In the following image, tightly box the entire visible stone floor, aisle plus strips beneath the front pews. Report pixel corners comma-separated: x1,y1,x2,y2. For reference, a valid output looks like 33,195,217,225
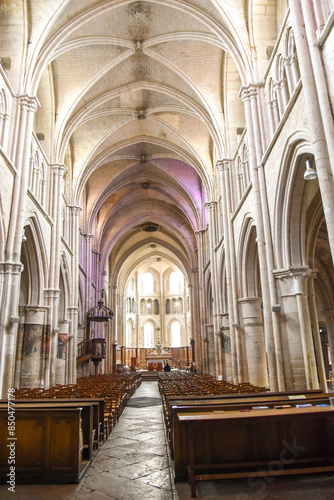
0,382,334,500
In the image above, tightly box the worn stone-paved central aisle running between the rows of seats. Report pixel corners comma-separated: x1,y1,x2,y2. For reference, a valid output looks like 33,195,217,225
74,382,179,500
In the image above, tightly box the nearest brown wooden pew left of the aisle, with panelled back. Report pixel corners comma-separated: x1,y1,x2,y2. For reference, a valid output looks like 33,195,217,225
0,406,88,484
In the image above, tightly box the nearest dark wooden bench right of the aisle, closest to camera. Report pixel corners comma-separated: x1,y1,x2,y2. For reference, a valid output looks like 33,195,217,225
177,406,334,498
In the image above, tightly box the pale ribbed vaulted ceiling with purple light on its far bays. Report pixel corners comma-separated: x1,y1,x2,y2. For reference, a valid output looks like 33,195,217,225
2,0,285,284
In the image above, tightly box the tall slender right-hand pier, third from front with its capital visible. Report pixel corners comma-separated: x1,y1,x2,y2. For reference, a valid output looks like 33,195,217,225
205,201,222,377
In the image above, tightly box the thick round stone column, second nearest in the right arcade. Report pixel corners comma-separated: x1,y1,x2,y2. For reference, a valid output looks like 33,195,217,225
239,297,269,387
